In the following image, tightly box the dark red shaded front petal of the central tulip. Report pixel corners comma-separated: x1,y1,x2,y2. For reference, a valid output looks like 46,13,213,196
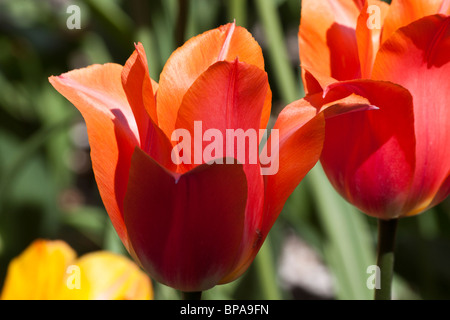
125,148,247,291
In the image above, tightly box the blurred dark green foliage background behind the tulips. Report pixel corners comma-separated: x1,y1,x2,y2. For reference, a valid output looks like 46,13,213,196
0,0,450,299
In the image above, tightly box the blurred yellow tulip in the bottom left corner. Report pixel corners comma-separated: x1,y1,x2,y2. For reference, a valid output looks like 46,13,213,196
0,239,153,300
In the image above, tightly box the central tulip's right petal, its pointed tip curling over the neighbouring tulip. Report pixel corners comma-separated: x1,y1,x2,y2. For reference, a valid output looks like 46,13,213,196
225,93,376,282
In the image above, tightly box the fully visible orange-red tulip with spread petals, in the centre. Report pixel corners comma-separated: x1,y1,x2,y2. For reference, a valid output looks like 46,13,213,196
50,23,367,292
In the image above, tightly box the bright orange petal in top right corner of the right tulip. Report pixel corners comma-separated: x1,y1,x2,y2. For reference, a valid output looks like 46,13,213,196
381,0,450,43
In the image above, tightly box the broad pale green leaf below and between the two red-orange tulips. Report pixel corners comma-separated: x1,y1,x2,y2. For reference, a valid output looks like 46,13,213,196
307,165,376,300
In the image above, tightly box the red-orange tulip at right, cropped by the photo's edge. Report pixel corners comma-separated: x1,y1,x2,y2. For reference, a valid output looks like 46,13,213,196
299,0,450,219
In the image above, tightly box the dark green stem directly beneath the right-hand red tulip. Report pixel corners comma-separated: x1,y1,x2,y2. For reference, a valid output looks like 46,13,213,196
375,219,398,300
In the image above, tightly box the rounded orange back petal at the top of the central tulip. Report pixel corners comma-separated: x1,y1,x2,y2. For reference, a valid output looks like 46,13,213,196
157,23,271,137
